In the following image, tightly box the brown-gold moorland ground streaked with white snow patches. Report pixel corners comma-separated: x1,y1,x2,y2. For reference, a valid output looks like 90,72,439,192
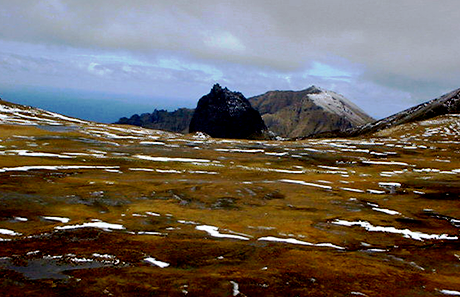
0,104,460,296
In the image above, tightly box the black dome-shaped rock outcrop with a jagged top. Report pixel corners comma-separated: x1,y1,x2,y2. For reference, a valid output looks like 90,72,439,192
189,84,267,139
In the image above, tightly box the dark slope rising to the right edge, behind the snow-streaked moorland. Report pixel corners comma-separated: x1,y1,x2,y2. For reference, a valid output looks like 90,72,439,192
345,89,460,136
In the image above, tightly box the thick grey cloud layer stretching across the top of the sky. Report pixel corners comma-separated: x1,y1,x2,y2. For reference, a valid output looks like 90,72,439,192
0,0,460,71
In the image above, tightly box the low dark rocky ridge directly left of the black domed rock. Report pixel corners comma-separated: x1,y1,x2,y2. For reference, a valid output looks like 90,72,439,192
115,108,194,133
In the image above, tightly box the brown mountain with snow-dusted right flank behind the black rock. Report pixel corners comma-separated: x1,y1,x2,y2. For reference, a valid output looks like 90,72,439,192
249,86,374,138
